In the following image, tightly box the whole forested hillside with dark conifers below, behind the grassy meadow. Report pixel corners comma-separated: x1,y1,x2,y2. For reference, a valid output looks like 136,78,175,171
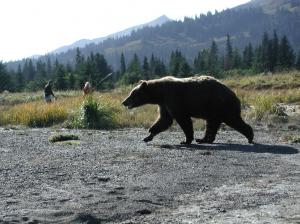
0,0,300,91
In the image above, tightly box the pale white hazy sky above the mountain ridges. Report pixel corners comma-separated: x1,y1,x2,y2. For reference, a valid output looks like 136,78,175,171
0,0,249,61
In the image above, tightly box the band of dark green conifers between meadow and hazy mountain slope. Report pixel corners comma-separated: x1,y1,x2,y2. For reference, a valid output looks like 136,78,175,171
0,31,300,92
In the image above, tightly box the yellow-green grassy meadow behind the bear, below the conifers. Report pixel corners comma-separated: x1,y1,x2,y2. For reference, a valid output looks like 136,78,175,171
0,71,300,129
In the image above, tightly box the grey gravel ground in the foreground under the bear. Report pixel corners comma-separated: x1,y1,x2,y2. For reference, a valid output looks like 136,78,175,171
0,128,300,224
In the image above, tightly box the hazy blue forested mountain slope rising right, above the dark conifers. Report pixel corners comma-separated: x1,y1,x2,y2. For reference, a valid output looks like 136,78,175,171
8,0,300,70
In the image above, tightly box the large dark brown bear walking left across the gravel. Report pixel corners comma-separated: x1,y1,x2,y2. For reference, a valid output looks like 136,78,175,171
122,76,253,144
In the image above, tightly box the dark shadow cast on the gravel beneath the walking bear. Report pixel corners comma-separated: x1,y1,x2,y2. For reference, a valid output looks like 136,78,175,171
158,143,299,154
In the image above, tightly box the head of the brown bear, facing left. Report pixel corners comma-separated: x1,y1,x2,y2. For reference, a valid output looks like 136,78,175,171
122,81,150,109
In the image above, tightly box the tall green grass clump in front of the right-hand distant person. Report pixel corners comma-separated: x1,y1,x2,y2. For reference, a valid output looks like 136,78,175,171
72,95,117,129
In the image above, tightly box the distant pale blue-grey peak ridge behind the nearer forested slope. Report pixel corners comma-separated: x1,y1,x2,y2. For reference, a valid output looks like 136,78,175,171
51,15,172,54
